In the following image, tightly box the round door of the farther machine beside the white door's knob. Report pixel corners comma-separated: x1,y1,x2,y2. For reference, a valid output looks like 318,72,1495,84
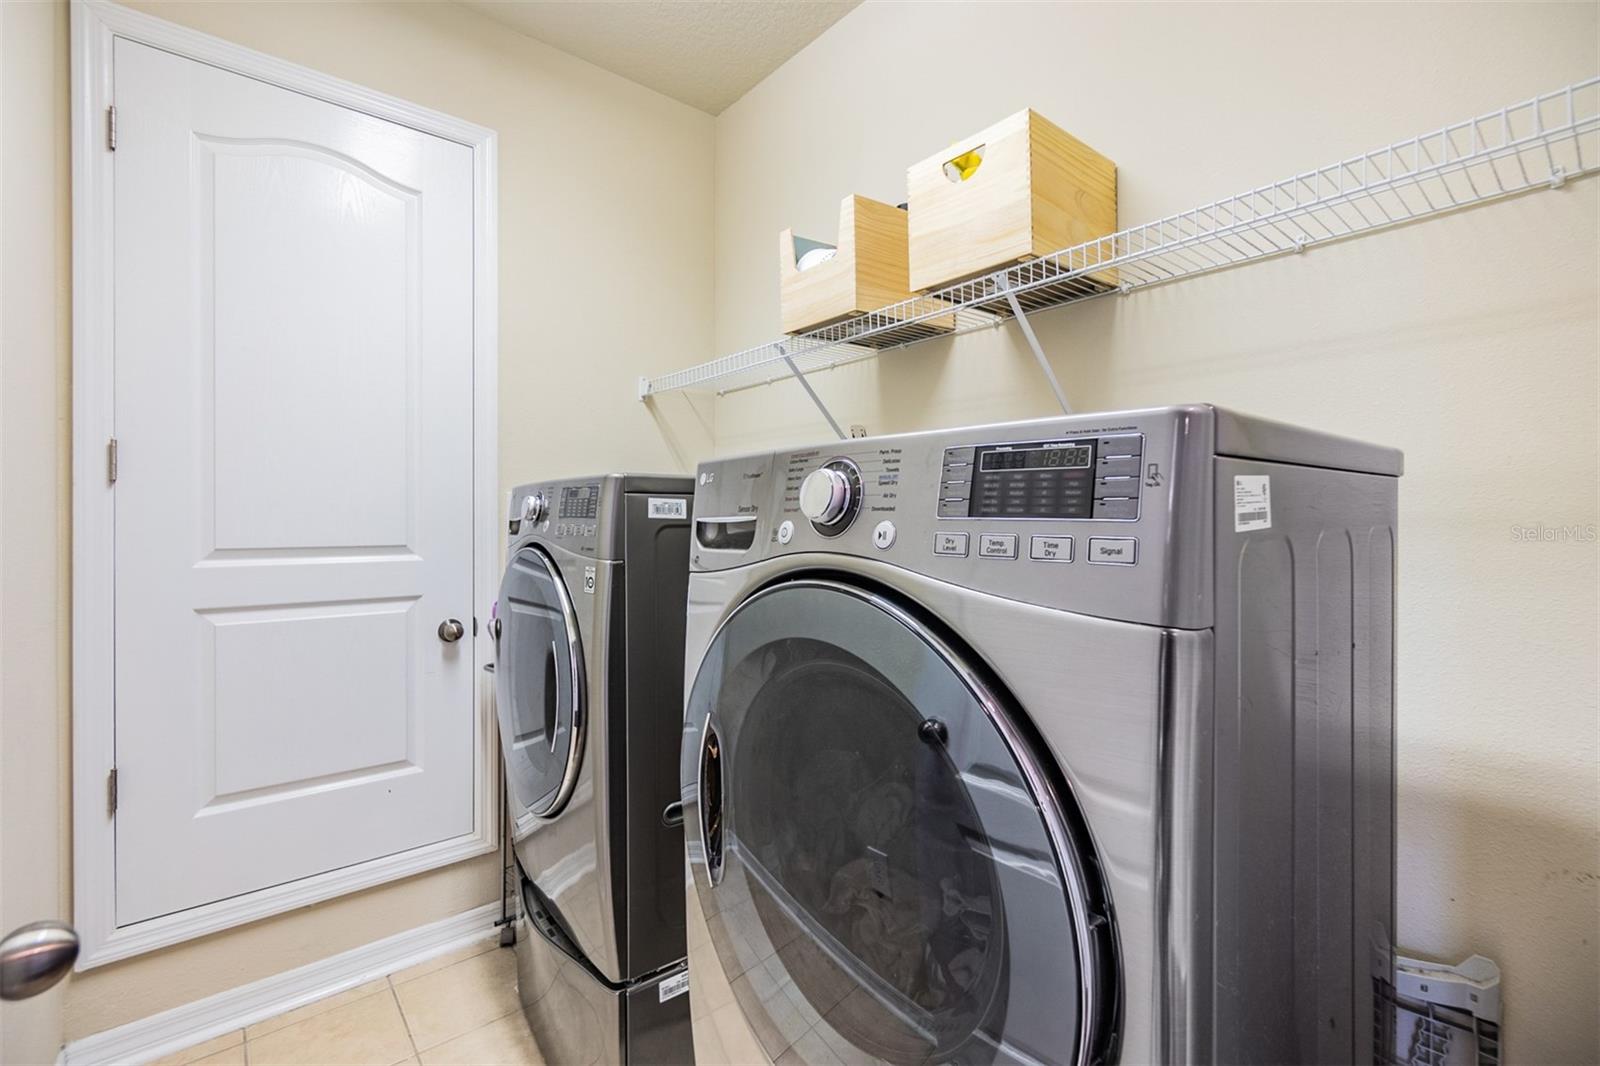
494,547,584,821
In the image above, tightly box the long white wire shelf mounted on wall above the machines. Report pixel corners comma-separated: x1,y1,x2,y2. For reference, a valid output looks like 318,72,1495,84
638,77,1600,404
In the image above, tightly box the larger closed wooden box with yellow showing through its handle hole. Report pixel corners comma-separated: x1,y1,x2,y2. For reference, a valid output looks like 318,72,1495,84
906,110,1117,291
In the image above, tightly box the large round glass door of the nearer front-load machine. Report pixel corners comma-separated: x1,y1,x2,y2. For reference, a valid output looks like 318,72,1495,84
682,579,1118,1063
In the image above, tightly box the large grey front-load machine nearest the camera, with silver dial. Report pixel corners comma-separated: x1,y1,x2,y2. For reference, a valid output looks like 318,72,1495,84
680,407,1400,1064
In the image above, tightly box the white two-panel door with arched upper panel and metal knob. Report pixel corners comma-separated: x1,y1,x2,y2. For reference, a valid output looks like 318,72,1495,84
114,38,474,925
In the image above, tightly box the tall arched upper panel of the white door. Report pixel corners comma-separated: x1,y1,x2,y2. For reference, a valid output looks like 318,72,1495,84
203,136,419,551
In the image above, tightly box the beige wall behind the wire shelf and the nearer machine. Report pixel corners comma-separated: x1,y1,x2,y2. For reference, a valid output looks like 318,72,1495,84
715,3,1600,1061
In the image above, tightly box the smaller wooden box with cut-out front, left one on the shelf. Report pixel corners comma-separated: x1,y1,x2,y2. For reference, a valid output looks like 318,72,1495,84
778,197,910,333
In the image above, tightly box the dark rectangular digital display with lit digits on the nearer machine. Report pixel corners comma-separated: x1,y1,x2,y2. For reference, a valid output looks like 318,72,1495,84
968,440,1094,519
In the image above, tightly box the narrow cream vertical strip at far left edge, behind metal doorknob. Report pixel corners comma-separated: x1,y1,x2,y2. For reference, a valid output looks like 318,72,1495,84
0,3,72,1063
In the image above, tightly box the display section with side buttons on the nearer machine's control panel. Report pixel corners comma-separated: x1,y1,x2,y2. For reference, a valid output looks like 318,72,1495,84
938,434,1144,522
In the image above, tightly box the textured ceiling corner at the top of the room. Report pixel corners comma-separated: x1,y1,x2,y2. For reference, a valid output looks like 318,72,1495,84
459,0,861,115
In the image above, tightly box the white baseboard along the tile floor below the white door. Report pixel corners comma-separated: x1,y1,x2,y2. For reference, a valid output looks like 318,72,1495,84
58,903,499,1066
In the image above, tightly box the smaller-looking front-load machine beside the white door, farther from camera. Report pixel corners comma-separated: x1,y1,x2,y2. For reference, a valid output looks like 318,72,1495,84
491,474,694,1066
